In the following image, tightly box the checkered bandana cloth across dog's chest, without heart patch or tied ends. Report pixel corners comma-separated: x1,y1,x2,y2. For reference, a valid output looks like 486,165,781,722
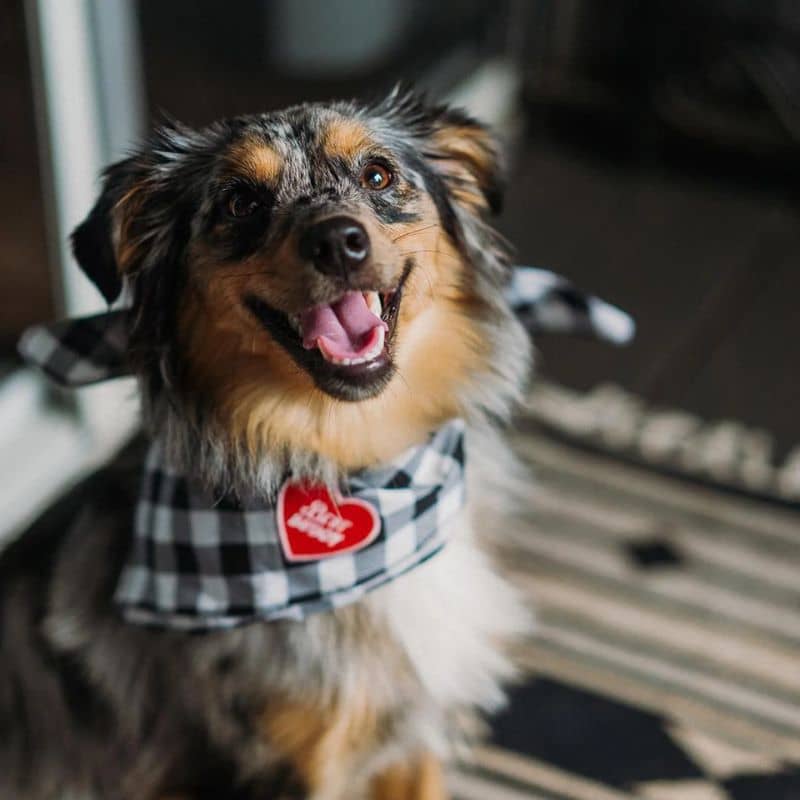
111,420,464,631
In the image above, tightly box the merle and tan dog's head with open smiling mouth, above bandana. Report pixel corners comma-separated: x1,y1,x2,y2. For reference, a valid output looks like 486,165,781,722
73,93,527,482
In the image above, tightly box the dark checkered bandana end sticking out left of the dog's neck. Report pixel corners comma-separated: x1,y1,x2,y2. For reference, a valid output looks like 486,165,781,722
18,309,130,386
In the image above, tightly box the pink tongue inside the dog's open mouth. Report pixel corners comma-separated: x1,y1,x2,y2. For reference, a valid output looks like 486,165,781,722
300,292,388,358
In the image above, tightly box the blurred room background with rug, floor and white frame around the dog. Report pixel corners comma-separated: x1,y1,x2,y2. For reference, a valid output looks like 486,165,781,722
0,0,800,800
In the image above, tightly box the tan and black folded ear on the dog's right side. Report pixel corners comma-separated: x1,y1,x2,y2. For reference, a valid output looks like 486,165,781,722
424,106,504,214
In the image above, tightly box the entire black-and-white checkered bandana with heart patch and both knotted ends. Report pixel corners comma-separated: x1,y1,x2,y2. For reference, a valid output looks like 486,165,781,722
19,267,633,631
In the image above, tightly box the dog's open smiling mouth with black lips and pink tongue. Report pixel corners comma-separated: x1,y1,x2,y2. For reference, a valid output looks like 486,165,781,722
245,264,411,400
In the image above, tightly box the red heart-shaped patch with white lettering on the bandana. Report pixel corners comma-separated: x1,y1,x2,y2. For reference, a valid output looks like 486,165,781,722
278,481,381,561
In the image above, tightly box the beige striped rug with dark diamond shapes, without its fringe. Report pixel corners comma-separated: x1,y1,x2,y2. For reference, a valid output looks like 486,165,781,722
452,430,800,800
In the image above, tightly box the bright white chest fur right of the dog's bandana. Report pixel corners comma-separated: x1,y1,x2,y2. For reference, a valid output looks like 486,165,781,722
367,430,532,728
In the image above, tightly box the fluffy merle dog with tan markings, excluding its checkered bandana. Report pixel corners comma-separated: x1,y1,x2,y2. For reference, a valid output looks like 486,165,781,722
0,90,544,800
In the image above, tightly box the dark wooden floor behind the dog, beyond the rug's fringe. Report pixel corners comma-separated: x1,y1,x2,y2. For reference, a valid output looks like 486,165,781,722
502,119,800,456
